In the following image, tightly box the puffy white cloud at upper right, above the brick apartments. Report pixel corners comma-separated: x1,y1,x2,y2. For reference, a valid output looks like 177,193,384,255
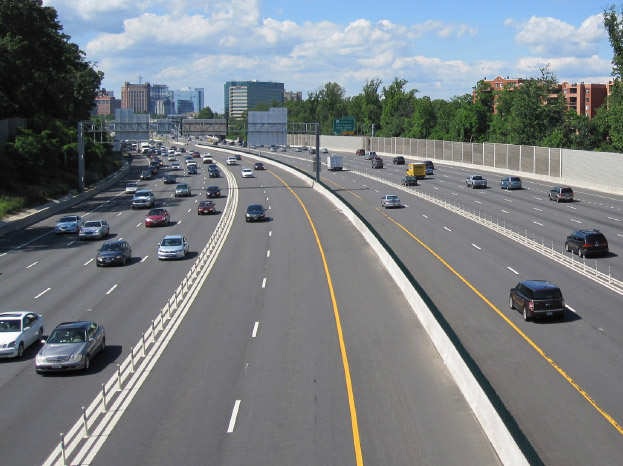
515,14,607,57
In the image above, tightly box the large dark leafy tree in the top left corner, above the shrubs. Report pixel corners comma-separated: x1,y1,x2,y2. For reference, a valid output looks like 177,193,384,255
0,0,103,124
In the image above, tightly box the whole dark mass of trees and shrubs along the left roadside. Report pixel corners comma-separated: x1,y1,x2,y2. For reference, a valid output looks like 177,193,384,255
0,0,112,208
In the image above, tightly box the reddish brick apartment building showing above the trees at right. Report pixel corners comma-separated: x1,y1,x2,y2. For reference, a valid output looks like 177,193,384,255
472,76,613,118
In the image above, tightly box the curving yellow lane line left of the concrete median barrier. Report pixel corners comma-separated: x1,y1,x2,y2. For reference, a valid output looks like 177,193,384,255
268,170,363,466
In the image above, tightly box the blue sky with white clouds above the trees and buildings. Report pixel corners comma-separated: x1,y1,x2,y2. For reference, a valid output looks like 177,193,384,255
43,0,619,113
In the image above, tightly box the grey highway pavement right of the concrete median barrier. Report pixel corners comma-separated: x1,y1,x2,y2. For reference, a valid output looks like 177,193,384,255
258,144,623,464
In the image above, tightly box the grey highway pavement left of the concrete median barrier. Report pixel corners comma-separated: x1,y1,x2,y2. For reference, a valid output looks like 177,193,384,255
0,150,499,465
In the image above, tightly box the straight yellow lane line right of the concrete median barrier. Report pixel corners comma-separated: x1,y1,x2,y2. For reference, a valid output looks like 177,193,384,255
383,213,623,435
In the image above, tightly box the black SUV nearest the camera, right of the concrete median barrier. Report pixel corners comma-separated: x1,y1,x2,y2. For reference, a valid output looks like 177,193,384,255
509,280,565,322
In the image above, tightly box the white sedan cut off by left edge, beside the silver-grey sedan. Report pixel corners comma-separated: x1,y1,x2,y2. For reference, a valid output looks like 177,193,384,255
0,312,43,358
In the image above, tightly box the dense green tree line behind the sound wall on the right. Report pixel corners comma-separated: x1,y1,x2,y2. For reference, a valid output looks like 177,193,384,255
285,6,623,152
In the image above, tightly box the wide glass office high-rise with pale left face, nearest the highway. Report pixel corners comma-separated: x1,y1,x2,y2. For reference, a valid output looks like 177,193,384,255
224,80,284,118
